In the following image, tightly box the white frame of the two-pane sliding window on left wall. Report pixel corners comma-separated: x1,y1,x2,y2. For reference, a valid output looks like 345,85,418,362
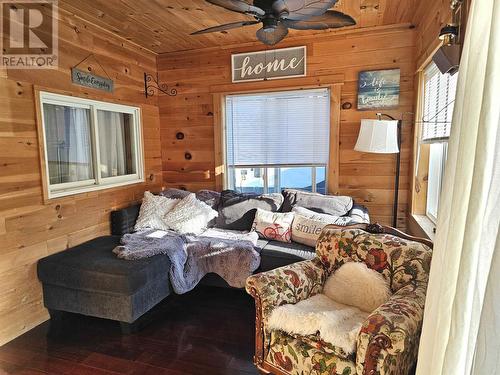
39,91,145,199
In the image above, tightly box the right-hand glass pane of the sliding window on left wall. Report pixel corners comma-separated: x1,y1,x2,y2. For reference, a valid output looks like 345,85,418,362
97,110,137,178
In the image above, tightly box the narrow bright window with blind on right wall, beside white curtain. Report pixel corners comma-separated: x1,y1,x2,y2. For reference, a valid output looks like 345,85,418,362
422,63,458,222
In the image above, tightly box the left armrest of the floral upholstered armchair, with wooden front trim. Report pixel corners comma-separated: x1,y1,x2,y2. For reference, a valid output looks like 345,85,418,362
246,258,327,368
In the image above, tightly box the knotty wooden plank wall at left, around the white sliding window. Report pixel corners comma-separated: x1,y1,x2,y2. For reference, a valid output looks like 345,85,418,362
0,11,161,345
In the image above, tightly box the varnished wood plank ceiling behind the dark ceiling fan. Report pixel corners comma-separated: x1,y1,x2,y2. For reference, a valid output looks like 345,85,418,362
59,0,417,53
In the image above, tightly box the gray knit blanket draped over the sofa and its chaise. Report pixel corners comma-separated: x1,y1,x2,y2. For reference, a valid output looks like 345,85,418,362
113,230,260,294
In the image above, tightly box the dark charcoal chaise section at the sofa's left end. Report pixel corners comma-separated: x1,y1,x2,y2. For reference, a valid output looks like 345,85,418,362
38,209,171,331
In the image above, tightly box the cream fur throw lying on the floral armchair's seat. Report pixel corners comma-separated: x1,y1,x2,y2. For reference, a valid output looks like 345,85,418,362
269,294,370,354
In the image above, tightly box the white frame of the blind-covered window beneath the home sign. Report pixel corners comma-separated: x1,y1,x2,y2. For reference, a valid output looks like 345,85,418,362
222,88,332,195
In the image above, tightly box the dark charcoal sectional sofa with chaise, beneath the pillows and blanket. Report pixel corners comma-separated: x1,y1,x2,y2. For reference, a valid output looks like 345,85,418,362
38,189,369,331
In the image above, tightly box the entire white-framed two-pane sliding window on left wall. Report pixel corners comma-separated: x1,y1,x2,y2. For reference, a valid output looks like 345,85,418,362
40,92,143,198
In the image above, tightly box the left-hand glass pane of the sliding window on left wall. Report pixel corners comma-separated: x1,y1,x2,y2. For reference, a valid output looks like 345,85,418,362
43,104,94,185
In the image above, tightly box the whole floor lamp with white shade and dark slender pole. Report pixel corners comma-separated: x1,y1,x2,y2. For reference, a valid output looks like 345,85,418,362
354,113,402,228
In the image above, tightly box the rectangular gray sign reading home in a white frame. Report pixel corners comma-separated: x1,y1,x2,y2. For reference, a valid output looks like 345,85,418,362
231,46,307,83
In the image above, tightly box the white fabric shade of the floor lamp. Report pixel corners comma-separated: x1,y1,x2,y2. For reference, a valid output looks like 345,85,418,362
354,120,399,154
